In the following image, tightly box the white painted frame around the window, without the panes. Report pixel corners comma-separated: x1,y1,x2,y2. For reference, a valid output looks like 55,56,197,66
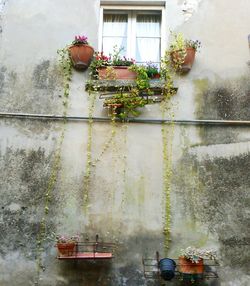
98,5,167,61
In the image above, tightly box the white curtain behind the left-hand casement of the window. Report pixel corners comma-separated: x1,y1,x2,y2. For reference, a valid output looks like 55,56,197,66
102,14,128,56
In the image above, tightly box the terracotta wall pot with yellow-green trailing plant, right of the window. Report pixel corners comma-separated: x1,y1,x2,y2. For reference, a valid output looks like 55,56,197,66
166,33,201,73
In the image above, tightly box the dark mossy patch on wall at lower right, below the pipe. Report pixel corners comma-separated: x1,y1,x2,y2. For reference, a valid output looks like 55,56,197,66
193,153,250,270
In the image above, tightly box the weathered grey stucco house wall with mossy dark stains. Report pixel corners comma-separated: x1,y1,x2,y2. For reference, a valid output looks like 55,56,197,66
0,0,250,286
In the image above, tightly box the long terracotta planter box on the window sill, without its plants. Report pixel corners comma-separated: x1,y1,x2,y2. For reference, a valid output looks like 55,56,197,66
98,66,136,79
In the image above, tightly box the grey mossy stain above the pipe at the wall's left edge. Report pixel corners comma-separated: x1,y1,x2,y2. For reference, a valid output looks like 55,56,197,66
0,60,62,114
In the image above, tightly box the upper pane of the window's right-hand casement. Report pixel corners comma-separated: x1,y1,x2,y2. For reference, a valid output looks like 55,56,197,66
136,14,161,37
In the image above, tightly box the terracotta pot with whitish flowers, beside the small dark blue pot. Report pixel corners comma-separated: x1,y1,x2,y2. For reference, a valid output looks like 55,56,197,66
179,246,216,274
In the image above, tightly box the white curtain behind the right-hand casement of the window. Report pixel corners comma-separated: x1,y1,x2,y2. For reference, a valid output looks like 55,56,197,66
136,15,161,63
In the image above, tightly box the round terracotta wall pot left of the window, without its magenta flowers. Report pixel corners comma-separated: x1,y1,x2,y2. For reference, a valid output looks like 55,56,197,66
69,44,94,70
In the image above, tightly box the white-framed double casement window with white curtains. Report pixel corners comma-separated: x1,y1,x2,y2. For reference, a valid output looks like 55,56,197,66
99,6,165,65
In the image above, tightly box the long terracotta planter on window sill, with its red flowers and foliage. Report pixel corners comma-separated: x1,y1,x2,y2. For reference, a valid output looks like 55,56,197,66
90,46,136,80
